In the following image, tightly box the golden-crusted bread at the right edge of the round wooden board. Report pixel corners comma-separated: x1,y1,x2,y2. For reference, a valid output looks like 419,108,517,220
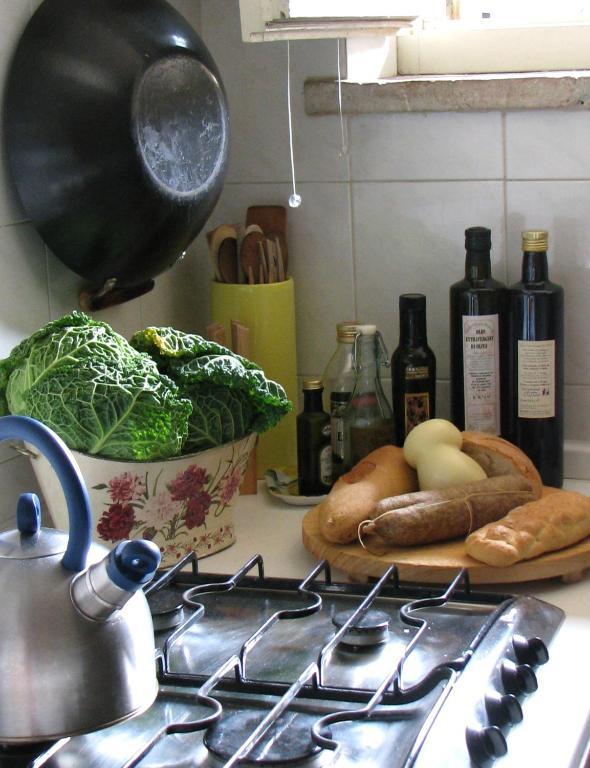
465,491,590,567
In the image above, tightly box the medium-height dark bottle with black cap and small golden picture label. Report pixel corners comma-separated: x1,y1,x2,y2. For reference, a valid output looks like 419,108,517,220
391,293,436,446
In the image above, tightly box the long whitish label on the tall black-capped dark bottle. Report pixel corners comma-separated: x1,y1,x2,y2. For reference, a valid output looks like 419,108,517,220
463,315,500,435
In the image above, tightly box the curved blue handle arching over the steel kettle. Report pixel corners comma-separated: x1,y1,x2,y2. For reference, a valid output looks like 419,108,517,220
0,416,92,571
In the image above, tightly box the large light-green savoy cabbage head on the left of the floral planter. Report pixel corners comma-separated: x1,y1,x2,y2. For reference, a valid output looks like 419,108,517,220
0,312,192,461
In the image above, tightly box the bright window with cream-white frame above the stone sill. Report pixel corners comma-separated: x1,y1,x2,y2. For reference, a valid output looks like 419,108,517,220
240,0,590,81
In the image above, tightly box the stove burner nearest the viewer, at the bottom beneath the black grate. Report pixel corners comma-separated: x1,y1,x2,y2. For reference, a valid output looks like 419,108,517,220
204,710,323,766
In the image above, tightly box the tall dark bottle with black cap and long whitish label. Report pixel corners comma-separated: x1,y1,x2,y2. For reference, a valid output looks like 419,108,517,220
450,227,508,435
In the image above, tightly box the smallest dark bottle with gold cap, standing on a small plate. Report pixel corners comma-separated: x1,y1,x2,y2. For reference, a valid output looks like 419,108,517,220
297,379,332,496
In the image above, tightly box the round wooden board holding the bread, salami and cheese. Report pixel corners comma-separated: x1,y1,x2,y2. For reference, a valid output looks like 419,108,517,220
303,488,590,584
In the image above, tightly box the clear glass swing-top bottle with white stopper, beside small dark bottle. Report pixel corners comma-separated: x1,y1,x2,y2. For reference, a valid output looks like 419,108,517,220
344,325,394,470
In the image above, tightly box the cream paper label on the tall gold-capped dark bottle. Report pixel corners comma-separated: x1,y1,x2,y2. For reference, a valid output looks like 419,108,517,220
518,339,555,419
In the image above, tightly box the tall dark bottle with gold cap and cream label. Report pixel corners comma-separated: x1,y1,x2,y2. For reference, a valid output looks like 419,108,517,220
507,230,564,488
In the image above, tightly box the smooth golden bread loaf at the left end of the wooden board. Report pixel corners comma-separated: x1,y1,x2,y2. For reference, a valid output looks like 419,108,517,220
317,445,418,544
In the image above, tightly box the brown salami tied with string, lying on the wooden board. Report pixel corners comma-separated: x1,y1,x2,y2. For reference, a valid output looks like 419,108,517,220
366,475,535,547
